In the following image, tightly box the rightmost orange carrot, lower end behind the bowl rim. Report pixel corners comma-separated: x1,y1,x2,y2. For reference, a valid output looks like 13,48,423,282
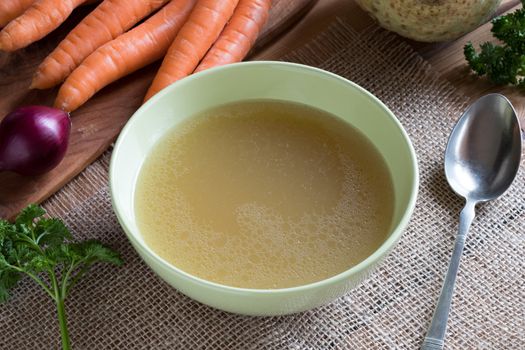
195,0,272,72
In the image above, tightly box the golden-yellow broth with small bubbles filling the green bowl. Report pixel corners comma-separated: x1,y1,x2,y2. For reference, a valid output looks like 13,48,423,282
135,100,394,289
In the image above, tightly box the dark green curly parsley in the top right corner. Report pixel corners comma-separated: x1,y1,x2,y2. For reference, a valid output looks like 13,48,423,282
464,0,525,88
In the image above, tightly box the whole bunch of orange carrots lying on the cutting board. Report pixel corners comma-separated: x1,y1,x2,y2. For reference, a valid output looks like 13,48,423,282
0,0,271,112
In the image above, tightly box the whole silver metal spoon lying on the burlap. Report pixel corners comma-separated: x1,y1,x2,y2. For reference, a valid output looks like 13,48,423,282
421,94,522,350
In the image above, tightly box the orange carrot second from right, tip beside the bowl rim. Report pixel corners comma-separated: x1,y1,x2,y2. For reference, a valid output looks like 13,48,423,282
144,0,239,101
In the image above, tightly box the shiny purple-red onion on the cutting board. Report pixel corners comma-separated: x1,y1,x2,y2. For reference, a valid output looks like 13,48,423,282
0,106,71,175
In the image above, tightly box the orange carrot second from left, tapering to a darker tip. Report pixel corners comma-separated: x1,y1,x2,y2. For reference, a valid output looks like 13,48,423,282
31,0,169,89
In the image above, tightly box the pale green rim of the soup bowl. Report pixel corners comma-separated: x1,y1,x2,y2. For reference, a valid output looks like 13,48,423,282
109,61,419,295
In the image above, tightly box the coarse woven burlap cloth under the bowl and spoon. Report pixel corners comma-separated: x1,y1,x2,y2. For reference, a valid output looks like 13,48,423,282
0,21,525,349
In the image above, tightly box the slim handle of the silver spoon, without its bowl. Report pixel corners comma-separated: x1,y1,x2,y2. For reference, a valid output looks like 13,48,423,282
421,200,476,350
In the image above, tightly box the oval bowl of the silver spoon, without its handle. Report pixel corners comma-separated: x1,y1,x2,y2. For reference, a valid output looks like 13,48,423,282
445,94,522,202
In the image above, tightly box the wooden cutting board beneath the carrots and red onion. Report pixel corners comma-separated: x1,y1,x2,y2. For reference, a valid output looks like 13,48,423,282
0,0,316,219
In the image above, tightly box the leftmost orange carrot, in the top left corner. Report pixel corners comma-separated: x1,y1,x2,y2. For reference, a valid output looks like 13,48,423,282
0,0,86,51
